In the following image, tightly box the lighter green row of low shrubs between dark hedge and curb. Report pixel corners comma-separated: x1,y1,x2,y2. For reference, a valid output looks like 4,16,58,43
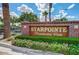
13,39,68,54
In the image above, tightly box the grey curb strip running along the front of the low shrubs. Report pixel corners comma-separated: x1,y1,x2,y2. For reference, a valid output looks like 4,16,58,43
0,42,63,55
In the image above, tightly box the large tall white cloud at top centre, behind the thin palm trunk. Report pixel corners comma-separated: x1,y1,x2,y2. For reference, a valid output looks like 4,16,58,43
35,3,54,21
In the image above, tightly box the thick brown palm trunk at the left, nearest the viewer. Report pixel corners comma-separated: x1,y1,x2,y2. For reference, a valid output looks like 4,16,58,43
2,3,11,38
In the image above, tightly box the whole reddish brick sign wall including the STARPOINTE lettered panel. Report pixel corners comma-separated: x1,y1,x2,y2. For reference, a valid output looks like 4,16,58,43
21,21,79,37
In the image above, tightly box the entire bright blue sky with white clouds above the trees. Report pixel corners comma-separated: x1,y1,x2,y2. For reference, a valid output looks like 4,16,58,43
0,3,79,21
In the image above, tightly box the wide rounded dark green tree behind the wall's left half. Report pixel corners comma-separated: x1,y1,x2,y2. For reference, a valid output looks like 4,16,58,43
18,12,38,22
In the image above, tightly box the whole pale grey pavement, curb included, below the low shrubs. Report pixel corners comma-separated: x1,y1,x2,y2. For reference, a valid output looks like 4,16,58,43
0,41,63,55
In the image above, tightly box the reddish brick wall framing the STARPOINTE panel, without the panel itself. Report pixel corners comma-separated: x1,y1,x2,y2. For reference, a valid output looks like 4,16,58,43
21,21,79,37
